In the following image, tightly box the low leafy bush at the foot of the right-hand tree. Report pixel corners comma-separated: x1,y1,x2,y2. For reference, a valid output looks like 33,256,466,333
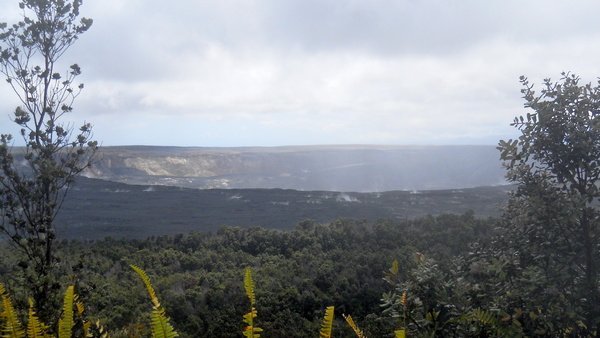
383,254,523,337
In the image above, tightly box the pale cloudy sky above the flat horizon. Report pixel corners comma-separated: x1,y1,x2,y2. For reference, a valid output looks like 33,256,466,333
0,0,600,147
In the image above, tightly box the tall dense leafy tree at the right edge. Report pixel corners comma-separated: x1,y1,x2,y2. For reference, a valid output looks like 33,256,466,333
498,73,600,332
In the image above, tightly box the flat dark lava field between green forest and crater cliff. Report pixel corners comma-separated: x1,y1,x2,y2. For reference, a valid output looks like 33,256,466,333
55,177,511,239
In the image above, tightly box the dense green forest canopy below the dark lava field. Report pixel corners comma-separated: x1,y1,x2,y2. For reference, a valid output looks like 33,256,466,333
0,212,494,337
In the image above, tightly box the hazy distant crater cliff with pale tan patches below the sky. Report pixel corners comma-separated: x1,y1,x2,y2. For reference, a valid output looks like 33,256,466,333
87,146,505,192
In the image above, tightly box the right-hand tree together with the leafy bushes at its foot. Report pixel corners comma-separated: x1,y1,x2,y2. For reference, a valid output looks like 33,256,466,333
384,74,600,337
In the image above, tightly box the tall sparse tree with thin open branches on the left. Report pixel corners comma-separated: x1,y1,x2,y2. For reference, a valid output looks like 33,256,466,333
0,0,98,322
